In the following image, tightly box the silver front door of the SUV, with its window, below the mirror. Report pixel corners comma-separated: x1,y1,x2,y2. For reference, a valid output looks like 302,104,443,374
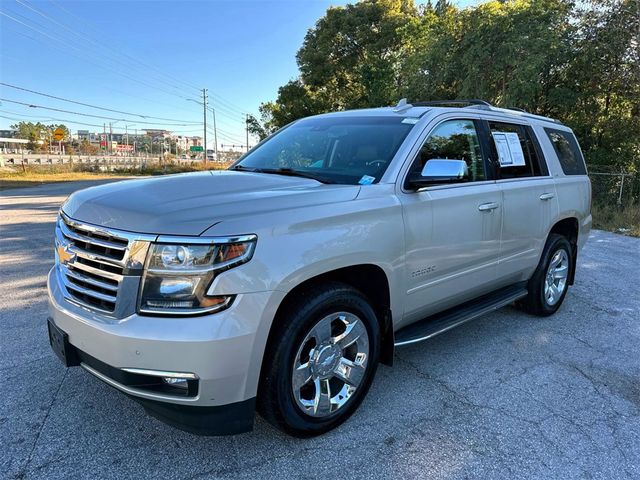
400,119,502,324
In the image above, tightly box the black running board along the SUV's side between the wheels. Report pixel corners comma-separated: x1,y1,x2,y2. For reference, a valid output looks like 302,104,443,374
395,282,528,347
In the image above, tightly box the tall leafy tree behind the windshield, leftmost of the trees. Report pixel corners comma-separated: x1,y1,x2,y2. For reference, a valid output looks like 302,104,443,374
260,0,417,132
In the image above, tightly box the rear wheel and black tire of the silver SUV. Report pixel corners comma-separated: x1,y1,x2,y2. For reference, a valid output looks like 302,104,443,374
518,233,575,317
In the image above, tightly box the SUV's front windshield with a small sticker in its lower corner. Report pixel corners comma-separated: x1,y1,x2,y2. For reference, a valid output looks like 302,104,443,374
231,116,413,185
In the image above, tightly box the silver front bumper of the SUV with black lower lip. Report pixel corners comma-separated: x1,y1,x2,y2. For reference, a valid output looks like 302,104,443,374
47,267,284,434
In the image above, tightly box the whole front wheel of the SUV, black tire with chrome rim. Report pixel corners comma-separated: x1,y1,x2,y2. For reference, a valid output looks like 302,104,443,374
258,282,380,437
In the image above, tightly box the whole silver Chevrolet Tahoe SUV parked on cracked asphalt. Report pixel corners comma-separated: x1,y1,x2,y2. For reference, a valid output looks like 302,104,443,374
48,100,591,436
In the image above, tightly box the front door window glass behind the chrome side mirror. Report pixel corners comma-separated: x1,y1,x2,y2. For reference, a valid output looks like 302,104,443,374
411,120,486,182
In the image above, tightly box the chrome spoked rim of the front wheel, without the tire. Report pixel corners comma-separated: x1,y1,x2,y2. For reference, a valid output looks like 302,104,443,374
291,312,369,417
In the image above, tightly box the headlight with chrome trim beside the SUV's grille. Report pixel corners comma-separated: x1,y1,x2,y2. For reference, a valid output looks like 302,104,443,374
138,235,256,315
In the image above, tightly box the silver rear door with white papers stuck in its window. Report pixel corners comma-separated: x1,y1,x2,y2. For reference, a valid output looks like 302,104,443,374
486,120,558,285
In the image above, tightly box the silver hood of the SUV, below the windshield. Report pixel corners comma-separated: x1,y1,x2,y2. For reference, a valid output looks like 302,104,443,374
62,170,359,235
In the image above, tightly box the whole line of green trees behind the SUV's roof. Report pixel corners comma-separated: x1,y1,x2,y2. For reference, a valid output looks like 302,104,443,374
249,0,640,176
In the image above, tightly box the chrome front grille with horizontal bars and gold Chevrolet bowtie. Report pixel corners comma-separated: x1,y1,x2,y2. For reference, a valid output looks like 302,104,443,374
56,213,155,318
